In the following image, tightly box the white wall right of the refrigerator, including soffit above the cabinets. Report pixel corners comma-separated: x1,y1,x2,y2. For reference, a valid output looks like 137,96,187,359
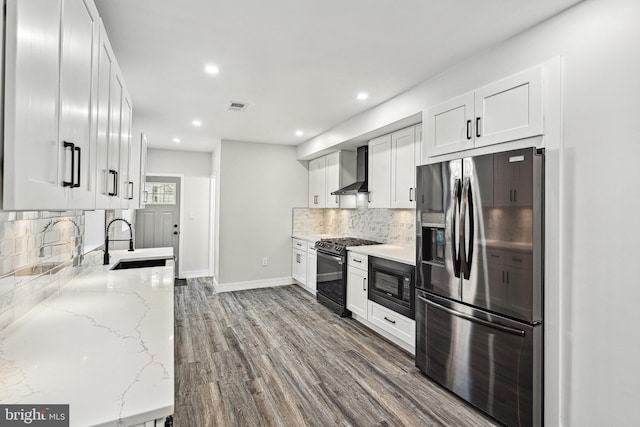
298,0,640,426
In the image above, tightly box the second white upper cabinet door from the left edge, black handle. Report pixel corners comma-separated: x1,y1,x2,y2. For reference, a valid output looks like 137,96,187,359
60,0,99,209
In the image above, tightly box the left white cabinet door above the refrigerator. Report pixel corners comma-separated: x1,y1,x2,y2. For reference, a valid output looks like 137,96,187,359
426,92,474,156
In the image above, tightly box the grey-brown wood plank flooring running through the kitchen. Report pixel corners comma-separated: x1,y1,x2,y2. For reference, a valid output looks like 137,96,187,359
174,279,496,427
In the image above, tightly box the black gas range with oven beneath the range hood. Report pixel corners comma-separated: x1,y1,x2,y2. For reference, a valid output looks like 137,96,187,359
315,237,380,317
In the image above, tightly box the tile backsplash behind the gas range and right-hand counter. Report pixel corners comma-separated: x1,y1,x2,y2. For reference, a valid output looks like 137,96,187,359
293,208,416,247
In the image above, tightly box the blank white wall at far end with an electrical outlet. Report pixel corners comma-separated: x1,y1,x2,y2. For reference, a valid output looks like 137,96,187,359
216,140,308,288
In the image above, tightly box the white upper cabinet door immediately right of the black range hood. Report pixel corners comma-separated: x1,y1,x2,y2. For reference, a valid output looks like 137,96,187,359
369,135,391,208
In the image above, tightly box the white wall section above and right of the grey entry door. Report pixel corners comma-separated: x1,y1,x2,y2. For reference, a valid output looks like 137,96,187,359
147,148,211,277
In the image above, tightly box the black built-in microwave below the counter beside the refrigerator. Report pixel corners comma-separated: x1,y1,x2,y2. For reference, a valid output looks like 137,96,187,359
368,256,415,319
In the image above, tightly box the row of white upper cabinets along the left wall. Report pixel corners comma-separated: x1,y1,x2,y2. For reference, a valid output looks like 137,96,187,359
3,0,132,210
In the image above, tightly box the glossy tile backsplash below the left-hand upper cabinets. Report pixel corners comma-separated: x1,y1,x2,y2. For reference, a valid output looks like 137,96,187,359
0,211,86,330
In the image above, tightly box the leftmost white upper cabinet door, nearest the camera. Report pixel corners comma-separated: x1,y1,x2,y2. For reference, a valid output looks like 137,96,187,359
3,0,71,210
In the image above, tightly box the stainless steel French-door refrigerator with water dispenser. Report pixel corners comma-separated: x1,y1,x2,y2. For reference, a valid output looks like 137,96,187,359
416,148,544,426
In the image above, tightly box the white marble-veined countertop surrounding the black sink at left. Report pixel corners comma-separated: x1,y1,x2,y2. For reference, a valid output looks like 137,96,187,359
0,248,174,427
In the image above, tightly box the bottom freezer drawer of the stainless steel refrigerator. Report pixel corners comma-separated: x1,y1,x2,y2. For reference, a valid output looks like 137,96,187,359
416,291,542,426
